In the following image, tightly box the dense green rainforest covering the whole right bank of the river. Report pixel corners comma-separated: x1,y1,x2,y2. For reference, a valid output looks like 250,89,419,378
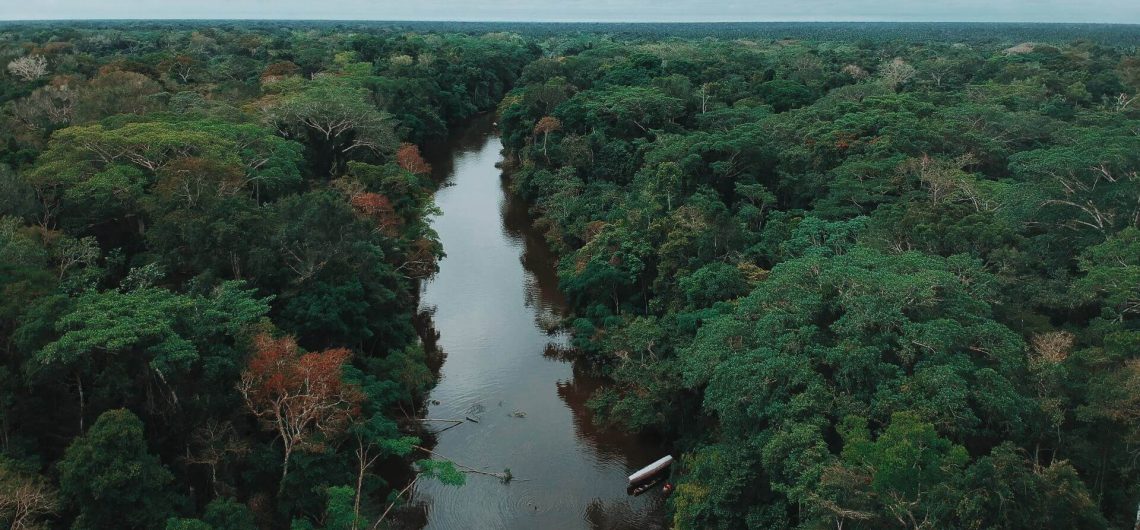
499,28,1140,529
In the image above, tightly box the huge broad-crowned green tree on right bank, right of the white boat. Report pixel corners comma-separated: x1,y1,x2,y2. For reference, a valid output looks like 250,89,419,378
665,242,1031,527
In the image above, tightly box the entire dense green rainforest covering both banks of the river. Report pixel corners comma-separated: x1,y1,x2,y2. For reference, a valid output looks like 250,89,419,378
0,22,1140,530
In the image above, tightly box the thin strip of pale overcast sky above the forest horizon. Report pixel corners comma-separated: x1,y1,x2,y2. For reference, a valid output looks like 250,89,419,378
0,0,1140,24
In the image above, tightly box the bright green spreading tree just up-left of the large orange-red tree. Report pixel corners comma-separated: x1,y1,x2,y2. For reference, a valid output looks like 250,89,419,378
27,282,269,432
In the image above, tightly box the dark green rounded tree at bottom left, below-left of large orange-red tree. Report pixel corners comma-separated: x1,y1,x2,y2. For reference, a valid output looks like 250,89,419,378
59,409,173,530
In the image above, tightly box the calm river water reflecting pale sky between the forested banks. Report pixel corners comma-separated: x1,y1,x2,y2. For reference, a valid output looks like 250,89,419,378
416,119,663,529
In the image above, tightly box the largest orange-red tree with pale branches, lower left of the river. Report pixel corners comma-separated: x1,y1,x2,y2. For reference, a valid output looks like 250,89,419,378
237,334,364,481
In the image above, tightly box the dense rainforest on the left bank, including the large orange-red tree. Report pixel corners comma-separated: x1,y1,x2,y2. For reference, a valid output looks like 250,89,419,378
0,22,538,530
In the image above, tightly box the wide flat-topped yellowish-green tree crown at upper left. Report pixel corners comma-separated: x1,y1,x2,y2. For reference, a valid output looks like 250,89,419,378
30,120,302,231
